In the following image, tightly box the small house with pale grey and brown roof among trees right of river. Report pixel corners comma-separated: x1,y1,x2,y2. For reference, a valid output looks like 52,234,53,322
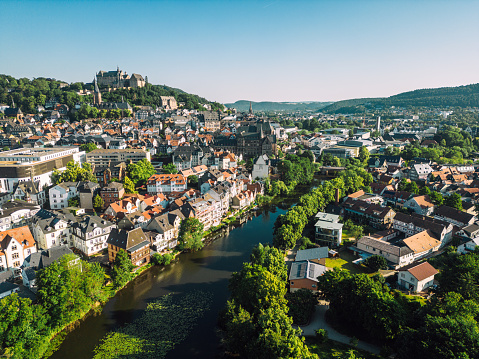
289,260,327,292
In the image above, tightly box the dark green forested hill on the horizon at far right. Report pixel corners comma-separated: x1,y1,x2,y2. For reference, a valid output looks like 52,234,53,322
323,84,479,113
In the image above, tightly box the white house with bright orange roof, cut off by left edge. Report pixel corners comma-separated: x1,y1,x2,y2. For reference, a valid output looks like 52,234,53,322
0,226,37,277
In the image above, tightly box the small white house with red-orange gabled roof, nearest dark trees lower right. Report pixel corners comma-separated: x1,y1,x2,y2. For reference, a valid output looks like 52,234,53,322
398,262,439,292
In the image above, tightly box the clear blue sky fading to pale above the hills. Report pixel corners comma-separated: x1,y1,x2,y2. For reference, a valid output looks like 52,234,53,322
0,0,479,102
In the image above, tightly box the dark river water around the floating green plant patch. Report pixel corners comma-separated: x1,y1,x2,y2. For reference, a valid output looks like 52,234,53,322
50,204,294,359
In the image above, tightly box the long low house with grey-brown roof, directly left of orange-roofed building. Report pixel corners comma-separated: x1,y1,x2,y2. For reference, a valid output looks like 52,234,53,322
351,236,414,268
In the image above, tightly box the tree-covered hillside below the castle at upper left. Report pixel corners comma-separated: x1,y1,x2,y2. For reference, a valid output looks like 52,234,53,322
0,75,223,113
